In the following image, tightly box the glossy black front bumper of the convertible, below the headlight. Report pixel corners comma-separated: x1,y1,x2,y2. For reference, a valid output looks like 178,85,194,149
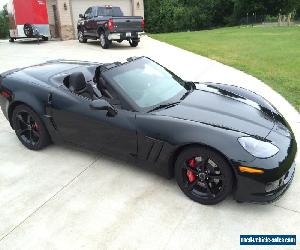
234,121,297,203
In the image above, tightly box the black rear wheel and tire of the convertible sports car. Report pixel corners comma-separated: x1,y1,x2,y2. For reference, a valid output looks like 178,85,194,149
12,105,51,150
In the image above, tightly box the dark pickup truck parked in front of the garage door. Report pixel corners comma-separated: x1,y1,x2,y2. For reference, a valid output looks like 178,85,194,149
77,6,144,49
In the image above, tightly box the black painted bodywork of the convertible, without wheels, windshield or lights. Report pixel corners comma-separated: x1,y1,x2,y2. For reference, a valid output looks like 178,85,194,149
0,59,297,202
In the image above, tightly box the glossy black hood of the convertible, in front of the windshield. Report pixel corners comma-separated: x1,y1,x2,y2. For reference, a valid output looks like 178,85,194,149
156,84,278,138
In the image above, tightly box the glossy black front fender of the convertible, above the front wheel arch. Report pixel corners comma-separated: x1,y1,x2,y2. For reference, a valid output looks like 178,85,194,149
137,115,255,163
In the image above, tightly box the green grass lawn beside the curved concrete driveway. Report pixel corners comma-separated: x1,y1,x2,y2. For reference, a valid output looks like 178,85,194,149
150,27,300,111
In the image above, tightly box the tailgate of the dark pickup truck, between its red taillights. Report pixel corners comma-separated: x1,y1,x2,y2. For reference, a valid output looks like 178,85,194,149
112,16,143,33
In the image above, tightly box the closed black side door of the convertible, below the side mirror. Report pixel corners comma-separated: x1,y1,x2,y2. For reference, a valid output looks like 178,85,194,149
51,91,137,155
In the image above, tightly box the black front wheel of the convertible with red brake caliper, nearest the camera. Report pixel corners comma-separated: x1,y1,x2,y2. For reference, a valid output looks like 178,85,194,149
175,147,233,205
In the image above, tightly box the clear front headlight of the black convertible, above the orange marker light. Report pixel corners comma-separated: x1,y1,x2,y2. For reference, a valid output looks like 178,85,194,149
238,137,279,158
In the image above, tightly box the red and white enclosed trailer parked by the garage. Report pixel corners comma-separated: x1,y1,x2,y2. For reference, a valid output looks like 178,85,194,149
7,0,50,42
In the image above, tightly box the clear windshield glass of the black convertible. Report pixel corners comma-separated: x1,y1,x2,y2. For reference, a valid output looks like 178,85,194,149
104,58,187,109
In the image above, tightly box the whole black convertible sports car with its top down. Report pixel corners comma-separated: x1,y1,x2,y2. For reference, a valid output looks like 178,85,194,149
0,57,297,204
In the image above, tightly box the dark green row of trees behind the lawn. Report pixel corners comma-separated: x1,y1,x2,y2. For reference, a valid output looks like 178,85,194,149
144,0,300,33
